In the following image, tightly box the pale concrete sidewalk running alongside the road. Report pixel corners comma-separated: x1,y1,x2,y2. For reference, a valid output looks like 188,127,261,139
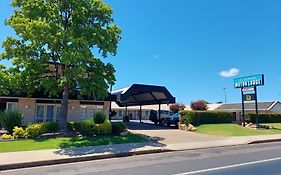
0,133,281,170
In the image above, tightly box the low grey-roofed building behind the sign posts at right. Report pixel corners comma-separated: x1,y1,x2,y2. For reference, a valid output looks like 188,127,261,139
216,101,281,121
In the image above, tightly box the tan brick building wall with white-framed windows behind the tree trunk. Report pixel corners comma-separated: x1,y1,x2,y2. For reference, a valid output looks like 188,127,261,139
0,96,109,125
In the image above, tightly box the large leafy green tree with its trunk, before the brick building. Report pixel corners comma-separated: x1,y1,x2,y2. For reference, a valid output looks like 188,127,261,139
0,0,121,130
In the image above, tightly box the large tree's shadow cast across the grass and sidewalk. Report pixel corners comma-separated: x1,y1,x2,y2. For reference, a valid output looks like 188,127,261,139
55,134,166,157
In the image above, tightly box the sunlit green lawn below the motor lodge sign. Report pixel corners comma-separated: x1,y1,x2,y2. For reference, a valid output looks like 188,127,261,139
197,123,281,136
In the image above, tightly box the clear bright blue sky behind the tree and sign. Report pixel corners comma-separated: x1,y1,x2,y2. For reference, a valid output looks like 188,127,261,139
0,0,281,103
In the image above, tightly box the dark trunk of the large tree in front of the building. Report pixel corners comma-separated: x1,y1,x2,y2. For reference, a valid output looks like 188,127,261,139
60,85,69,132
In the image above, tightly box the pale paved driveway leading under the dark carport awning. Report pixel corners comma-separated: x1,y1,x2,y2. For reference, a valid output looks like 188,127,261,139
127,122,227,145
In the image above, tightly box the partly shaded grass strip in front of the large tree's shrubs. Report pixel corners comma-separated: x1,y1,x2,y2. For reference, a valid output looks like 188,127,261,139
0,134,147,152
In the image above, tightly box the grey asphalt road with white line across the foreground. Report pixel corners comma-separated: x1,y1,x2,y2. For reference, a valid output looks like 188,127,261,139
0,142,281,175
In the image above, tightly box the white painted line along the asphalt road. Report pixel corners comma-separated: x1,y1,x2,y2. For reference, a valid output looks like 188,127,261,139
173,157,281,175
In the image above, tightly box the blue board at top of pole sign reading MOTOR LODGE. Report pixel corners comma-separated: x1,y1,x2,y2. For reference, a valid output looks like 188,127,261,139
234,74,264,88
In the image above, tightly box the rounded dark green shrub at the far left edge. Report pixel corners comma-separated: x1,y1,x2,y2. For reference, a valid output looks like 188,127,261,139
0,111,23,133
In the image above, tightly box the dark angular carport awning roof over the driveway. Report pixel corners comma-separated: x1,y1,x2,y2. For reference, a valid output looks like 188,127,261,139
107,84,175,107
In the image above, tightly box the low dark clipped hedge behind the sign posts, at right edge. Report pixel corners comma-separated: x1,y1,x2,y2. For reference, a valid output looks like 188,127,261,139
245,113,281,123
